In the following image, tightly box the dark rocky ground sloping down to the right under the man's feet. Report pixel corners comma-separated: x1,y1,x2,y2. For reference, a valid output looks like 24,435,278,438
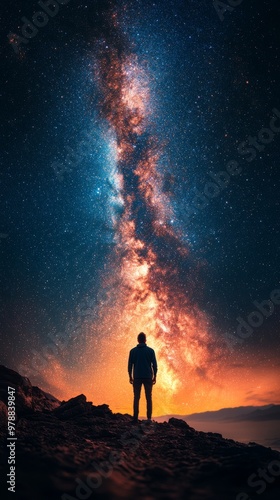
0,366,280,500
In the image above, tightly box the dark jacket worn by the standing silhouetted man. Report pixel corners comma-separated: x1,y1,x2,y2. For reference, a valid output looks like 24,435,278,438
128,342,157,378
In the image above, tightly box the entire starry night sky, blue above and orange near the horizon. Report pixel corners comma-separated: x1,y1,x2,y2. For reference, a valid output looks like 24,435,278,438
0,0,280,415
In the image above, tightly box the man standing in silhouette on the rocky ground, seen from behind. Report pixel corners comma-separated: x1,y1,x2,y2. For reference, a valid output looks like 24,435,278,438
128,332,157,423
